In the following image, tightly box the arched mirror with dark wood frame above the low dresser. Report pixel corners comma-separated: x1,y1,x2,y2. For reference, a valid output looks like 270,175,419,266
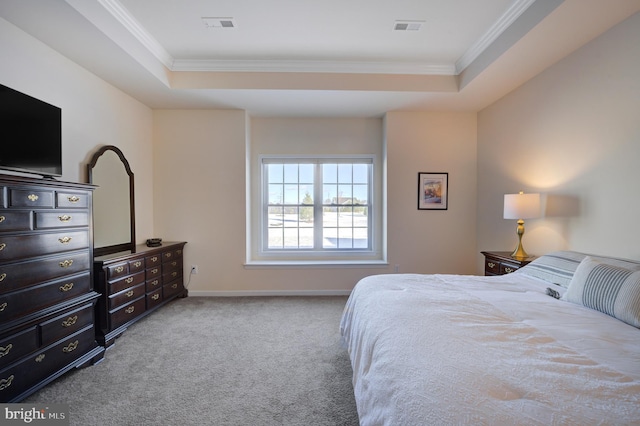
88,145,136,256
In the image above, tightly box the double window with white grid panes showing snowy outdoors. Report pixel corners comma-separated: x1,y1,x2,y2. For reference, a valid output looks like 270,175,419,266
261,157,374,257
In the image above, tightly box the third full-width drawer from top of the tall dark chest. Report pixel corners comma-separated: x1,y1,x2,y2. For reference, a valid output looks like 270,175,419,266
0,272,91,322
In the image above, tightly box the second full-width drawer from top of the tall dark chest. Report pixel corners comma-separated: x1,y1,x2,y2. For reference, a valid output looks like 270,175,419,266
0,250,91,294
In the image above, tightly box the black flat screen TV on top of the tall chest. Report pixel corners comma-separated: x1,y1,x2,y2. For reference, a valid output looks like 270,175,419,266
0,84,62,177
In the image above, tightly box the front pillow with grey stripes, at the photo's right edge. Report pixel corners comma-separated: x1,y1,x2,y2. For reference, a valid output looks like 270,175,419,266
562,256,640,328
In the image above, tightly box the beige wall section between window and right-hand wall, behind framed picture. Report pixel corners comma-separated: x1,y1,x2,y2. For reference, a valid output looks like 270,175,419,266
386,112,477,274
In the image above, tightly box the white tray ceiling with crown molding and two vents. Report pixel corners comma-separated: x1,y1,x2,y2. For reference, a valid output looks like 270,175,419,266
0,0,640,116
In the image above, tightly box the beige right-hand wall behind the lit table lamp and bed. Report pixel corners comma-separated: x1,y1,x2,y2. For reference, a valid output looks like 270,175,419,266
477,14,640,268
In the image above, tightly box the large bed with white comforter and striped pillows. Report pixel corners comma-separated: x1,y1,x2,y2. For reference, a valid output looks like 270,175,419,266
340,251,640,426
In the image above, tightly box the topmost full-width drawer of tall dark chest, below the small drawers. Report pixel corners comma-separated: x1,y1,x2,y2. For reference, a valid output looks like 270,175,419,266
0,231,89,262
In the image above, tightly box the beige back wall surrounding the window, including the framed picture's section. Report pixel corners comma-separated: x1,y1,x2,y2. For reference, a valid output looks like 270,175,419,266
154,110,476,295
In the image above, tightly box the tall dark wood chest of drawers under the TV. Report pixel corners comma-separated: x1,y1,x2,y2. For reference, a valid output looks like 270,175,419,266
0,176,104,402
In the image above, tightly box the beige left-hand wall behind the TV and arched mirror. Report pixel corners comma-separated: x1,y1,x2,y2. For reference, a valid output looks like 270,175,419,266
0,19,153,242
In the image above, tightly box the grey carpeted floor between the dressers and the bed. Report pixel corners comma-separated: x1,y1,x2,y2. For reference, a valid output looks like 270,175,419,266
25,297,358,426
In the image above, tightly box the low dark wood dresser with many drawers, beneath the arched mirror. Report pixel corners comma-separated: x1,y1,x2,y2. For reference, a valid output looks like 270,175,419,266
94,242,187,347
